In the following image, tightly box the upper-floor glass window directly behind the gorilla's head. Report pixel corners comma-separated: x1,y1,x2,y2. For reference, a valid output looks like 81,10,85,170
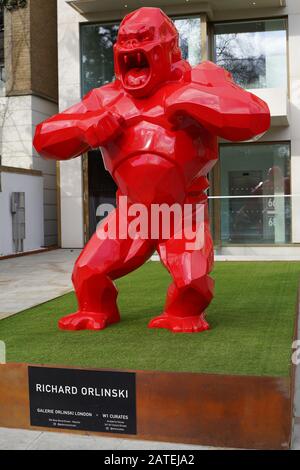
81,17,201,95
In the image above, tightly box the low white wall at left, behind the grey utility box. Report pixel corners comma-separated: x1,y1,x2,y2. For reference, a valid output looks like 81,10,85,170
0,172,44,256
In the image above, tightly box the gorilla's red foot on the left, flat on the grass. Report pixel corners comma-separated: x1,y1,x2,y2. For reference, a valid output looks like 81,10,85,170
58,312,120,331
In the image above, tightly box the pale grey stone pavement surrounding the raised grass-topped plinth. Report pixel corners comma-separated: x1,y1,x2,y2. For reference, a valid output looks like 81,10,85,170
0,250,300,450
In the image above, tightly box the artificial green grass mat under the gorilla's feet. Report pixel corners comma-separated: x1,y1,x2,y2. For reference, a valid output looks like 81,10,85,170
0,262,300,376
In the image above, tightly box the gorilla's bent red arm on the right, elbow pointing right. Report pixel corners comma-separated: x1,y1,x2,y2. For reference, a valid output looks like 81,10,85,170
166,61,270,141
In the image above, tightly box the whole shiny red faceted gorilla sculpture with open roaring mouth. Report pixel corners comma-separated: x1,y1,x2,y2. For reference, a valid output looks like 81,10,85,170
34,8,270,332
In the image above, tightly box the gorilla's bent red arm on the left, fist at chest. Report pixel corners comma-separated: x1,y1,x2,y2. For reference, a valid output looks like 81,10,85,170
33,89,122,160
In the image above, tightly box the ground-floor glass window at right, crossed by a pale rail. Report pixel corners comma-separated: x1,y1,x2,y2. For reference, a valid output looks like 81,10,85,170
220,143,291,244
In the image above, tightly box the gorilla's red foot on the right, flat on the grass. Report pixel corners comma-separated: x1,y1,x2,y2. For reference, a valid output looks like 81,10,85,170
148,313,209,333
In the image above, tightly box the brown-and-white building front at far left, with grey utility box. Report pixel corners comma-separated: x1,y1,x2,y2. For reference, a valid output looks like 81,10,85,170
0,0,58,256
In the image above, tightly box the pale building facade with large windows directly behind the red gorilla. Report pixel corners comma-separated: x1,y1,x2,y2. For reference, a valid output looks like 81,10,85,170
58,0,300,258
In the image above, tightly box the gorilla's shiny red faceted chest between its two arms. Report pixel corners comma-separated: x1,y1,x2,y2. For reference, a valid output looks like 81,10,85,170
102,87,216,180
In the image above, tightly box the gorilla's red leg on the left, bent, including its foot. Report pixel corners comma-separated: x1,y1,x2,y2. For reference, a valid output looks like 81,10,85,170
59,209,154,330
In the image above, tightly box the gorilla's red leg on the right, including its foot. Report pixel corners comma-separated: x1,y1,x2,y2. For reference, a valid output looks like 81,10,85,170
149,215,214,333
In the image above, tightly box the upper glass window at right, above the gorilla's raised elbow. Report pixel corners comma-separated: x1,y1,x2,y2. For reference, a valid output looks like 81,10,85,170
214,18,287,89
